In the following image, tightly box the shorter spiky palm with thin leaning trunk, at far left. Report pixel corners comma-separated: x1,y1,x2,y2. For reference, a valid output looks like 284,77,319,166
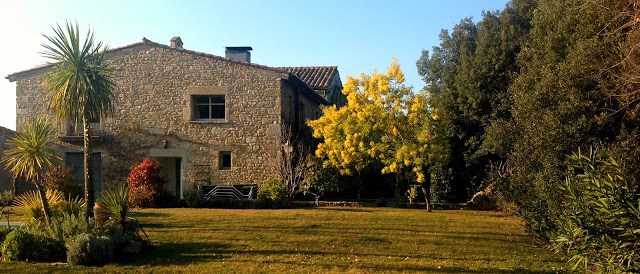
2,117,60,225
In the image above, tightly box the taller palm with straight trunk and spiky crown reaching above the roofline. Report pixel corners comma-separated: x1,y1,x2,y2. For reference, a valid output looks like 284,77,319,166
42,22,115,217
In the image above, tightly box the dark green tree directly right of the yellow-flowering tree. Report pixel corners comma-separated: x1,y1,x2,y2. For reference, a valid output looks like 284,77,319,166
417,0,535,200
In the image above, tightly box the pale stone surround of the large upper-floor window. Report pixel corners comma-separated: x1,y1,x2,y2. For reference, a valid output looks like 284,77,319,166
183,86,232,124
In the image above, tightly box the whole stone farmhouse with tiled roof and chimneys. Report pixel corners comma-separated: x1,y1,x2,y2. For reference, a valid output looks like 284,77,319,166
6,37,346,197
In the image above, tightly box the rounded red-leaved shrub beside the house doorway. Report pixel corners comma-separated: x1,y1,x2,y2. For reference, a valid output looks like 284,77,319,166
127,158,167,207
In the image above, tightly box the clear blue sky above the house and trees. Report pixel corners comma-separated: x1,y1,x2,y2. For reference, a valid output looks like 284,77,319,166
0,0,507,129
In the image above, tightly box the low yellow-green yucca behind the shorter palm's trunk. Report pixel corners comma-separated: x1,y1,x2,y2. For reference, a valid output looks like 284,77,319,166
13,190,64,224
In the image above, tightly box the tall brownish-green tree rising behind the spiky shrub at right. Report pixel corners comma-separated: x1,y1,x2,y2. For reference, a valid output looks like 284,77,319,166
488,1,632,240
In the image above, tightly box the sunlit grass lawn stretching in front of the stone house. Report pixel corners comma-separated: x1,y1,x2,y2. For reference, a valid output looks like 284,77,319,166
0,208,567,273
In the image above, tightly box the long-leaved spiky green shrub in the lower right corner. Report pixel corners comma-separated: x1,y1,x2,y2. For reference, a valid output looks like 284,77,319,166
555,151,640,273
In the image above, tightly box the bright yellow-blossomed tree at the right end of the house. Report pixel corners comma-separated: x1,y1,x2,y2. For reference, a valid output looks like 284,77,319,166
308,61,447,210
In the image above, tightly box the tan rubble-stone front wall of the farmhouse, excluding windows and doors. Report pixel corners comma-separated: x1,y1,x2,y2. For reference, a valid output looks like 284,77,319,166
11,44,317,194
